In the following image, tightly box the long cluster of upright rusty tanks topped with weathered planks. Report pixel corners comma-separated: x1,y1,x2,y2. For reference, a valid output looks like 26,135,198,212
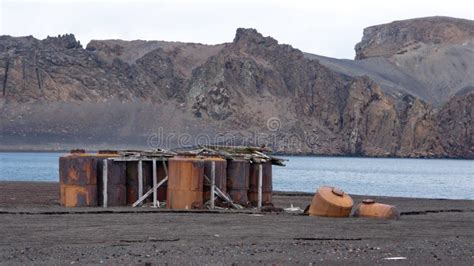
59,147,283,209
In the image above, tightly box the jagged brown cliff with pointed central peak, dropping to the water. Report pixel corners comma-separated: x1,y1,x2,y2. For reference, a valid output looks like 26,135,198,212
184,29,443,156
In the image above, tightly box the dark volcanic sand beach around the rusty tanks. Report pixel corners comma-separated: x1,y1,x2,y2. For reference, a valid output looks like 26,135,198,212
0,182,474,265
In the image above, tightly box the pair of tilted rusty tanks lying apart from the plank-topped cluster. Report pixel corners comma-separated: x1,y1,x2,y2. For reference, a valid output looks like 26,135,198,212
305,186,400,219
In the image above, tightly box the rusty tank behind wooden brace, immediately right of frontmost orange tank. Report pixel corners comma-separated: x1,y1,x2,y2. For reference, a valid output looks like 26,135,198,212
203,156,227,205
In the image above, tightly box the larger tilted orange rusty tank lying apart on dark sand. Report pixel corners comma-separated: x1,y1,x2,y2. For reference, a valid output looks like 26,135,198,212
308,187,354,217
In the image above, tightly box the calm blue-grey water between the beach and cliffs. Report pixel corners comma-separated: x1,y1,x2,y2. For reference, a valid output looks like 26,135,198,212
0,153,474,199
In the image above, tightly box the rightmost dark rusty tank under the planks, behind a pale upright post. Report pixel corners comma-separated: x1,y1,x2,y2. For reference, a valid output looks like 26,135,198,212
248,161,273,206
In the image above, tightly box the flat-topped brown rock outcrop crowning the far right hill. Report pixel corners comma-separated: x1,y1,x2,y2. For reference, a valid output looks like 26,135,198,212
355,17,474,59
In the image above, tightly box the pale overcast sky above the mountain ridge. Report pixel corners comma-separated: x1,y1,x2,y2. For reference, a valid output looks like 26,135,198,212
0,0,474,58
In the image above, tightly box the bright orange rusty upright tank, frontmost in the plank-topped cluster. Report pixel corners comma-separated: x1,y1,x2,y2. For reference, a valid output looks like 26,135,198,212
166,155,204,209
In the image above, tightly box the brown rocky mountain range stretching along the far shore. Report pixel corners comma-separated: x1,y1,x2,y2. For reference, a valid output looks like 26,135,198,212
0,16,474,158
